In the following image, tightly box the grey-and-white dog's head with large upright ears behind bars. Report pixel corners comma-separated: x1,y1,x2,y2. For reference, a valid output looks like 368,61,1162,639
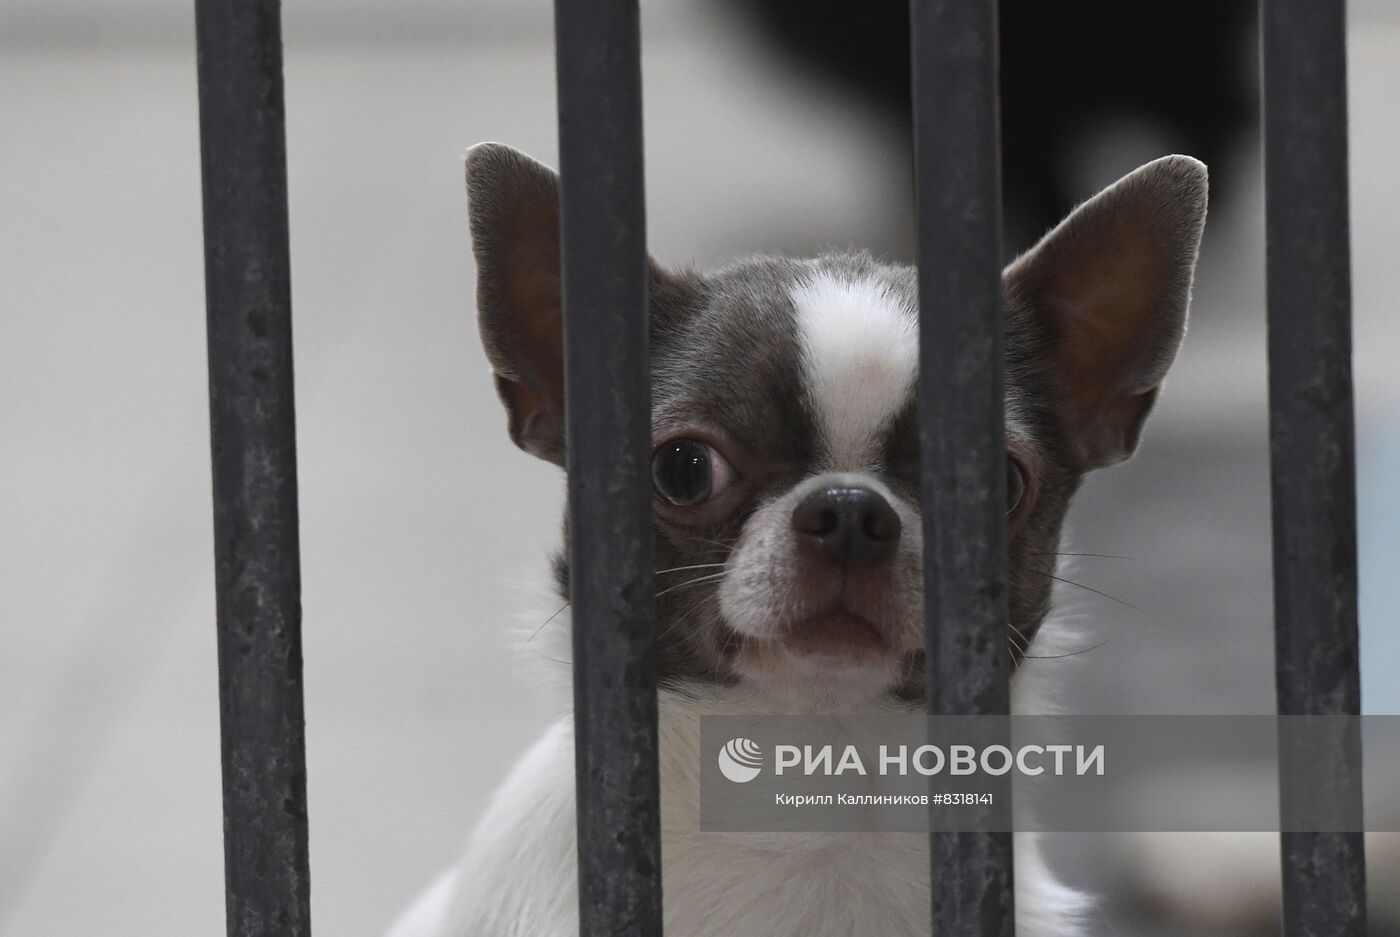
466,144,1207,699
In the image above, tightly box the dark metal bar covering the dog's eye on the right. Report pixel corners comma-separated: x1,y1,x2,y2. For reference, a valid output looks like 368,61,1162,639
911,0,1015,937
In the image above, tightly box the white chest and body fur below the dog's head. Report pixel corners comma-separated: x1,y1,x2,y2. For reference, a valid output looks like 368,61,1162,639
391,680,1084,937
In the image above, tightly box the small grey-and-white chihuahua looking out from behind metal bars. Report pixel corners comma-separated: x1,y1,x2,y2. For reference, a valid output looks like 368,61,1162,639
391,143,1207,937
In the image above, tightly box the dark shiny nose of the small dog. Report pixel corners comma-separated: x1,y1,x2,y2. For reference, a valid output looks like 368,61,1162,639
792,487,900,567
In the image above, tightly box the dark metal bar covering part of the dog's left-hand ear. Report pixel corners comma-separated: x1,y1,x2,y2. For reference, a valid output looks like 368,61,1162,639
554,0,661,937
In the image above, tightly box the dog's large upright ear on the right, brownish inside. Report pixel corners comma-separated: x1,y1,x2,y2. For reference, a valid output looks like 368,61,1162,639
1005,155,1207,471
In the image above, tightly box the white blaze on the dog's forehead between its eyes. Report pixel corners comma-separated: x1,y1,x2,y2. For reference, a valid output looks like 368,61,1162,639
792,273,918,469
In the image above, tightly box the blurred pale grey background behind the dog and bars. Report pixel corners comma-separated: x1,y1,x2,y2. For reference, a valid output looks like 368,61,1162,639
0,0,1400,937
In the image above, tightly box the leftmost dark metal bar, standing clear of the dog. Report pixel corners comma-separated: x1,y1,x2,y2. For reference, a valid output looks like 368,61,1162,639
195,0,311,937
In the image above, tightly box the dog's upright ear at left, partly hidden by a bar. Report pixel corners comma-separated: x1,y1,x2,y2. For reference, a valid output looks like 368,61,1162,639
466,143,564,465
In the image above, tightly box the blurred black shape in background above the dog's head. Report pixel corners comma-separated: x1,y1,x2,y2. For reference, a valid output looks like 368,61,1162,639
725,0,1259,248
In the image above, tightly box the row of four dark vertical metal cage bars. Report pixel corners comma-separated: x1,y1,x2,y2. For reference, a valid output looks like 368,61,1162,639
196,0,1365,937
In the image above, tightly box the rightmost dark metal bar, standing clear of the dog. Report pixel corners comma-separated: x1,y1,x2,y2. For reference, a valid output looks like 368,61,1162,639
1263,0,1366,937
